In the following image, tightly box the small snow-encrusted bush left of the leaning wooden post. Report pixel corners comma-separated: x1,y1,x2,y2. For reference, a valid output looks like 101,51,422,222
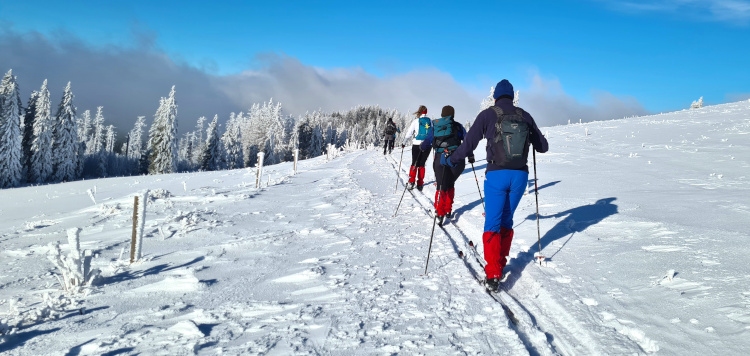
47,227,100,293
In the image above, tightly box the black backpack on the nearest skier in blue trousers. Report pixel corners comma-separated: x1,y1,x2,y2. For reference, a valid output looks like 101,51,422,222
492,106,530,169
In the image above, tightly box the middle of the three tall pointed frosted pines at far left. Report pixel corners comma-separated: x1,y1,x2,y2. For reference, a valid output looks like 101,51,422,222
29,80,53,183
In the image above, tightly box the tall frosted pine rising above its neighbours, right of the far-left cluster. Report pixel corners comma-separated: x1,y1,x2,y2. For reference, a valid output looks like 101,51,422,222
148,86,177,174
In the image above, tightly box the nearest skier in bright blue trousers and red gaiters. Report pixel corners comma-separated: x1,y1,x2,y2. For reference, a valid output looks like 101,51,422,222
441,79,549,290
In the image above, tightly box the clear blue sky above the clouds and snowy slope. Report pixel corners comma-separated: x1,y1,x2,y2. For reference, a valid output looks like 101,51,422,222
0,0,750,127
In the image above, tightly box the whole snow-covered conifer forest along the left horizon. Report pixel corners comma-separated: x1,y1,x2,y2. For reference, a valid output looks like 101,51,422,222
0,70,408,188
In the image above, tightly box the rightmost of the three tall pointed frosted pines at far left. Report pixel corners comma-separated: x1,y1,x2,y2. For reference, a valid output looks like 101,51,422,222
52,82,79,182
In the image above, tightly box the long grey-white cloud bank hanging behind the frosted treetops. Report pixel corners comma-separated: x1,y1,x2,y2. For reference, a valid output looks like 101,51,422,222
0,26,647,133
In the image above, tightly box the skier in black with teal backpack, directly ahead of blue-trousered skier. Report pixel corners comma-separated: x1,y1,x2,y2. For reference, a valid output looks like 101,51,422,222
420,105,474,226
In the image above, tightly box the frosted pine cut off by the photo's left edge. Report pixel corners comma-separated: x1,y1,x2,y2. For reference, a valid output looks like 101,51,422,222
0,71,23,188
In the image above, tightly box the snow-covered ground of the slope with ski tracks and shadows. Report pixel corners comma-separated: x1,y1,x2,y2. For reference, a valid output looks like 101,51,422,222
0,102,750,355
